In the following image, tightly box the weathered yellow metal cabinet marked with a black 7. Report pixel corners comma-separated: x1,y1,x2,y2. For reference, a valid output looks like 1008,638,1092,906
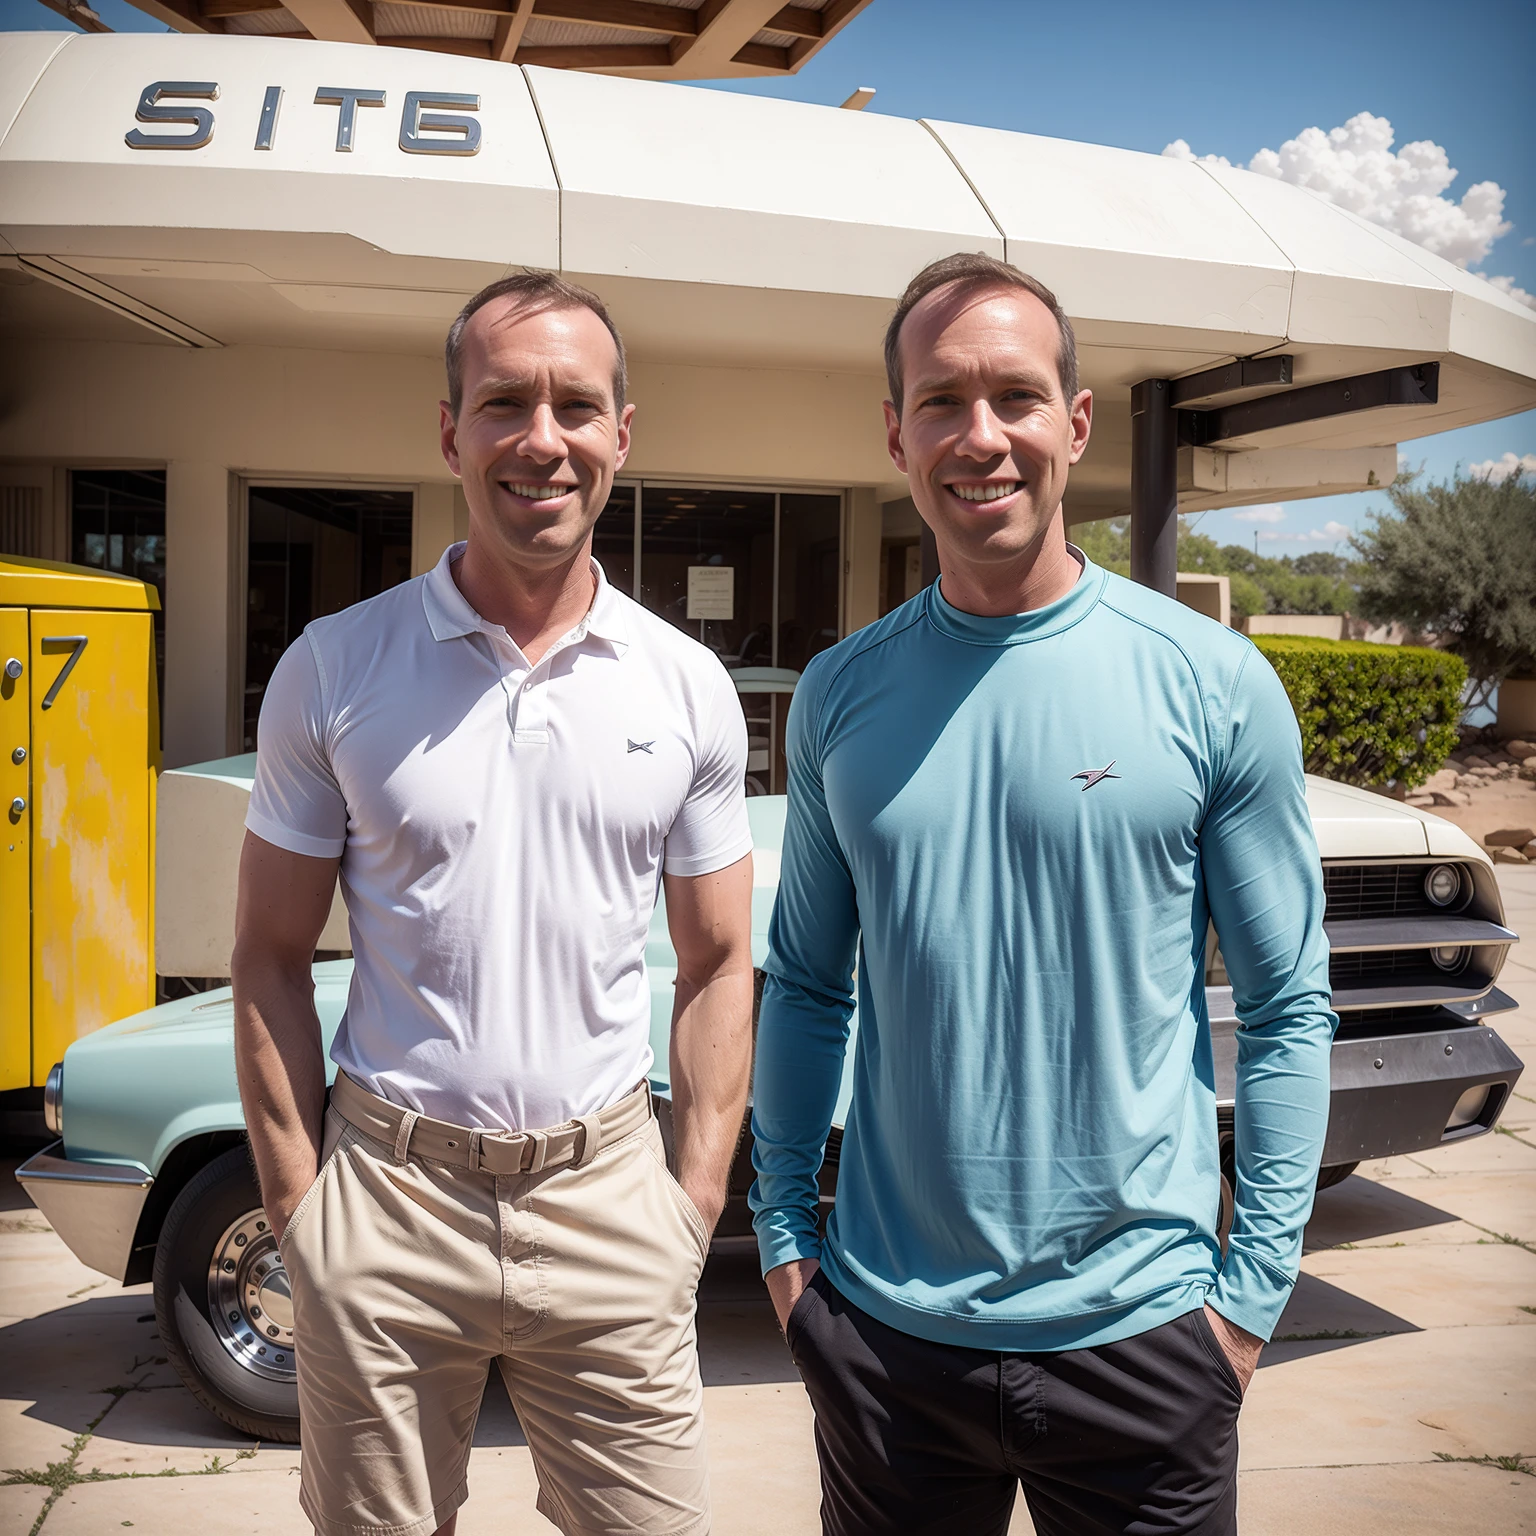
0,554,160,1091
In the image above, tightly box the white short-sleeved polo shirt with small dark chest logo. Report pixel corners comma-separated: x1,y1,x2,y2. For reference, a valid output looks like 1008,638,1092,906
246,544,753,1130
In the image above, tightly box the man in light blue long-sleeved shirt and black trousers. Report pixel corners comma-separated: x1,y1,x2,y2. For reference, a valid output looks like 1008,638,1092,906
753,257,1336,1536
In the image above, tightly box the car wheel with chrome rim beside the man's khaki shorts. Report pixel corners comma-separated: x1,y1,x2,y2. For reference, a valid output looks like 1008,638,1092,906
155,1146,298,1444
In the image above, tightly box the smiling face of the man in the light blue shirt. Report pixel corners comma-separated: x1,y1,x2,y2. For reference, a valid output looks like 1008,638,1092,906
885,284,1094,578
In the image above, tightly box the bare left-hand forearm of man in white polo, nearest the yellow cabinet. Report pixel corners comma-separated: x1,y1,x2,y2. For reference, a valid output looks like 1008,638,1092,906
230,949,326,1238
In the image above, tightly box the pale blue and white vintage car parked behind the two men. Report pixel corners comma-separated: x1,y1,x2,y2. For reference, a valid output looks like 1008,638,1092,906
17,780,1521,1441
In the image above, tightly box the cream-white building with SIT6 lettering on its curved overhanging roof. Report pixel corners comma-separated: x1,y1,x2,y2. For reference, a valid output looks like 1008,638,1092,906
0,34,1536,768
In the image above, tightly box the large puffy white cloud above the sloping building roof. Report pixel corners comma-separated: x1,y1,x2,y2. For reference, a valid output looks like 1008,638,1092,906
1163,112,1513,278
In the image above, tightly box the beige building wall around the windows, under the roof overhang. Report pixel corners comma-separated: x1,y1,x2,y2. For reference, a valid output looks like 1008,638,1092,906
0,341,902,766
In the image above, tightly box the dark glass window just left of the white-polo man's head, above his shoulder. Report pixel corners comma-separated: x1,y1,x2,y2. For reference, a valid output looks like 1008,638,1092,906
243,485,412,753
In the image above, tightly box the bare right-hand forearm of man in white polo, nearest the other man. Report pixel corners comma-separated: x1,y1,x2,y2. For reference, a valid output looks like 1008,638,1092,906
671,954,753,1227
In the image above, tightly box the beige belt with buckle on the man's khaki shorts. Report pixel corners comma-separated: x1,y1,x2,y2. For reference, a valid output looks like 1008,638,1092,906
330,1072,651,1177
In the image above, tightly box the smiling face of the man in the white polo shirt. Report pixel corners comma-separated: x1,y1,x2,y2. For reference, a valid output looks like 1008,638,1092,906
441,298,634,573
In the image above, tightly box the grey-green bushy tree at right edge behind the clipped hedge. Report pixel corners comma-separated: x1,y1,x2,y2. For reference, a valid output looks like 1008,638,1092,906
1350,470,1536,707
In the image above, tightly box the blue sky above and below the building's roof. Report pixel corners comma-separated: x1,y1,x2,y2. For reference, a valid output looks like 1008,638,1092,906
12,0,1536,553
